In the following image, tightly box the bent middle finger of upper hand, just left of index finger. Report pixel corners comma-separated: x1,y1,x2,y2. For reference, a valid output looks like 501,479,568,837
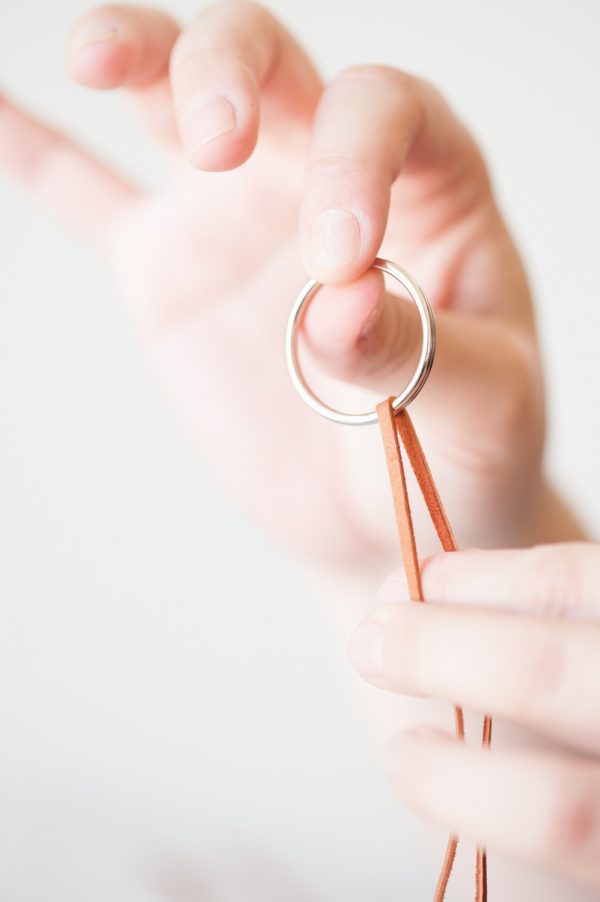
171,2,320,170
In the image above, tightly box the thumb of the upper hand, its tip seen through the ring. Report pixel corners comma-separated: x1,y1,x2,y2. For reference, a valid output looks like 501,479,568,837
300,269,541,451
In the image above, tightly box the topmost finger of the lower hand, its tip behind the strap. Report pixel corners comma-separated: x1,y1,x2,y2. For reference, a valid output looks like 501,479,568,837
377,542,600,619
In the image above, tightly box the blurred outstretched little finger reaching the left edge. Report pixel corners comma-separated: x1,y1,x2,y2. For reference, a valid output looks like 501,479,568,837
0,98,138,245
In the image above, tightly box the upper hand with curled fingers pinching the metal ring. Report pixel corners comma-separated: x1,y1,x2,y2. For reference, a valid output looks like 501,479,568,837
0,2,546,572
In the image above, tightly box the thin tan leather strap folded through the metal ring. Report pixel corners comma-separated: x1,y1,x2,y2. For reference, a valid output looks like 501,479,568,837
377,397,492,902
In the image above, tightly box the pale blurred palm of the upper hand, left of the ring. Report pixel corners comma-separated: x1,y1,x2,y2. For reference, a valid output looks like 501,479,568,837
112,137,370,560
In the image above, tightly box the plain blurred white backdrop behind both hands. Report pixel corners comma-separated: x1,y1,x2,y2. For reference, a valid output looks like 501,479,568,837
0,0,600,902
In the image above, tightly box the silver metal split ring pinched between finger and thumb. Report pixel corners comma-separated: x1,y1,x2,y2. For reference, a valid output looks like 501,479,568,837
285,257,435,426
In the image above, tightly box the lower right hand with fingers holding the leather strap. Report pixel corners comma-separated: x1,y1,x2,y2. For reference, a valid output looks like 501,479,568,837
351,543,600,887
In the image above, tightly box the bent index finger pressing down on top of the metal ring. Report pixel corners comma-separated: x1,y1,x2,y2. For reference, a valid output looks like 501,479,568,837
301,66,491,283
